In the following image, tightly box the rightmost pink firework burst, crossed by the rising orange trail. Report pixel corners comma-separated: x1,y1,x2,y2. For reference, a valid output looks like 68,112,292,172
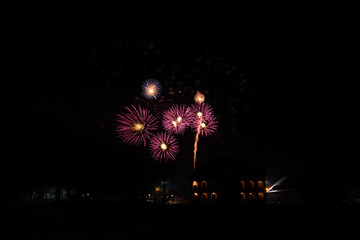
191,103,218,137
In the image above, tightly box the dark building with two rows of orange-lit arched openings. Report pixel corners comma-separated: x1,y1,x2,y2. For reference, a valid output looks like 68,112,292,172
189,158,266,203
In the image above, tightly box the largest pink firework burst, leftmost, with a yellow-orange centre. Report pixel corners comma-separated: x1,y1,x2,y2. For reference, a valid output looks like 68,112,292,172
116,105,157,146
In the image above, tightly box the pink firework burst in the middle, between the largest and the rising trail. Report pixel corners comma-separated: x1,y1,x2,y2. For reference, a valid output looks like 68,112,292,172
162,104,191,134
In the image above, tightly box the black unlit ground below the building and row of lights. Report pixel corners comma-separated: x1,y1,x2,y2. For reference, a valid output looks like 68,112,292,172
0,203,360,239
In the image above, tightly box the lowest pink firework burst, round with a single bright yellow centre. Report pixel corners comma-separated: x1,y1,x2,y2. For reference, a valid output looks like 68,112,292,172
150,132,179,162
